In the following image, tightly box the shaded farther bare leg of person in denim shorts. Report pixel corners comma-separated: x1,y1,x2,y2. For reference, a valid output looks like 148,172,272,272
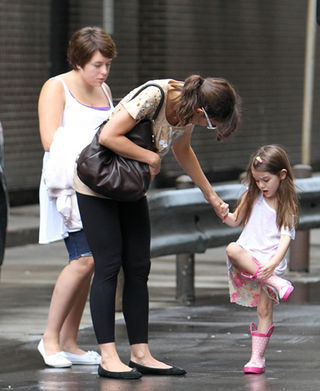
59,269,93,354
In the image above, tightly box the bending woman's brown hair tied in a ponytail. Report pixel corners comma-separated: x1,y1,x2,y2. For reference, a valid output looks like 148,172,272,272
170,75,240,141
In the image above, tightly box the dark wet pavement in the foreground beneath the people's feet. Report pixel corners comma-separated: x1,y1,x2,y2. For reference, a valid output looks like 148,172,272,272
0,298,320,391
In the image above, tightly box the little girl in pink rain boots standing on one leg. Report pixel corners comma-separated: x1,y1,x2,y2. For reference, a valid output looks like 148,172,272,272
224,145,298,373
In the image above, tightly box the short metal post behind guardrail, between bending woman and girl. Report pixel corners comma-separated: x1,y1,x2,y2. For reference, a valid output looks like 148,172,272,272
176,175,195,305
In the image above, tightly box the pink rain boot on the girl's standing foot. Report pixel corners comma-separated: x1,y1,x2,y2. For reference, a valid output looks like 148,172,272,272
243,323,274,374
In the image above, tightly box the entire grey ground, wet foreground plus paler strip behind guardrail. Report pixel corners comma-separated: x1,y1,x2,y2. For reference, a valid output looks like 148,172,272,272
0,207,320,391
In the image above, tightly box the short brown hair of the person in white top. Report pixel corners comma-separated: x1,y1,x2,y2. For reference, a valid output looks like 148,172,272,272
67,27,117,70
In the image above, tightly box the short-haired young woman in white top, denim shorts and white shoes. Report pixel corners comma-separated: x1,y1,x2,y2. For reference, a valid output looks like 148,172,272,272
38,26,116,368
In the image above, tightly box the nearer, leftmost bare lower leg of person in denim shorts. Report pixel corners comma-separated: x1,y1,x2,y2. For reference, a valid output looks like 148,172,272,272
43,257,94,355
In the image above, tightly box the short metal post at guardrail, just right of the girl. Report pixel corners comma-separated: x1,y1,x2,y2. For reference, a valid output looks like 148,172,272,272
290,164,312,272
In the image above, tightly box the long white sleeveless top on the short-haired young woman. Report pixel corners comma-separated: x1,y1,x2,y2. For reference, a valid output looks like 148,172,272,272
39,76,113,243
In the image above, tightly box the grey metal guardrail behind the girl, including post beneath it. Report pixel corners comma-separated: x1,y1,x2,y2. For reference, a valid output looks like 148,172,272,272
148,177,320,303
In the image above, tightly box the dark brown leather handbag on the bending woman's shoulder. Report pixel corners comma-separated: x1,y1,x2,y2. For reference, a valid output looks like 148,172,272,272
77,84,164,202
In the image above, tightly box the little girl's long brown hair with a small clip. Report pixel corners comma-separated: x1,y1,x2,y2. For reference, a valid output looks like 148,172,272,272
237,145,298,229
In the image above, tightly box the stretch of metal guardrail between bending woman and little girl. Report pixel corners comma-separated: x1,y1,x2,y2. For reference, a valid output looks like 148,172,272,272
148,184,244,257
